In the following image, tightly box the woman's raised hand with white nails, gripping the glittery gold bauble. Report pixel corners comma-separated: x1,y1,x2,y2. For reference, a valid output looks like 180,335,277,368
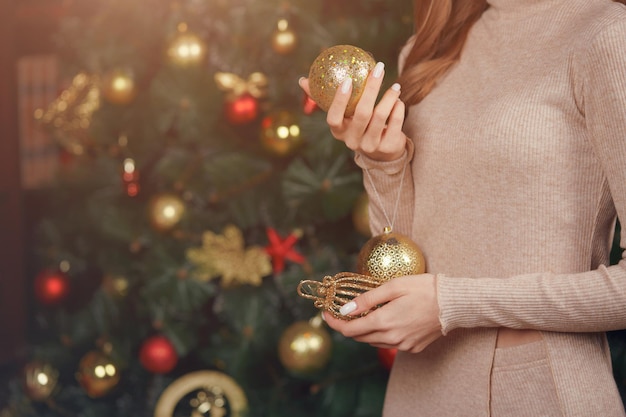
299,62,407,161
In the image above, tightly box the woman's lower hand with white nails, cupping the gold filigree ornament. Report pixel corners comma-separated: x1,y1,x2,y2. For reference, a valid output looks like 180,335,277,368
324,274,442,353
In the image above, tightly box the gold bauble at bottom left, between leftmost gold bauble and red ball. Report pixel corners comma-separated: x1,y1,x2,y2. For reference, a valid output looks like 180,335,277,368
76,350,121,398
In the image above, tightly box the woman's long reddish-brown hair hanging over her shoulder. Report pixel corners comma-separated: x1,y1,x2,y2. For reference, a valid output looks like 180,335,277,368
398,0,626,105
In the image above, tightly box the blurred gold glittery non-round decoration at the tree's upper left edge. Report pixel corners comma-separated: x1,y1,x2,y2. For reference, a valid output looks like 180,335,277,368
34,72,101,155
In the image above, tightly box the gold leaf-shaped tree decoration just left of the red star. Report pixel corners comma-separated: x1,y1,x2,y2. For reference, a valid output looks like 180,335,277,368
187,225,272,287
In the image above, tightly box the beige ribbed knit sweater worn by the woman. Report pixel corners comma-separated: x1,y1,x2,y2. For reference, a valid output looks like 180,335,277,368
356,0,626,417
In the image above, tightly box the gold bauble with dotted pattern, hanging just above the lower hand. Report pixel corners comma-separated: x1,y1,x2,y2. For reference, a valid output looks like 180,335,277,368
356,228,426,283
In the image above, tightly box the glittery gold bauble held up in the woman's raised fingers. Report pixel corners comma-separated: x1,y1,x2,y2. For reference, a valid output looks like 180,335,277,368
309,45,376,117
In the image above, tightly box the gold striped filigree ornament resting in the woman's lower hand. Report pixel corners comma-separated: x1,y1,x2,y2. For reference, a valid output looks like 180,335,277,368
297,272,382,320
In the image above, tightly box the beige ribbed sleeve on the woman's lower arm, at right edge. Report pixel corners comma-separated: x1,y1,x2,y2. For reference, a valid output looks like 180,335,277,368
438,19,626,334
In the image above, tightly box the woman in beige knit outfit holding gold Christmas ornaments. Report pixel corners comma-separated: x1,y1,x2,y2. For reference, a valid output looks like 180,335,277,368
300,0,626,417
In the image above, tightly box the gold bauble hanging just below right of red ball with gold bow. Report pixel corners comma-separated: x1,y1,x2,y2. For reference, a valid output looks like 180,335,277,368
260,109,304,157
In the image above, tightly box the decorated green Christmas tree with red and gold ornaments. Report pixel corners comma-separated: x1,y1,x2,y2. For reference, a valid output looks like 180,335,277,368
2,0,412,417
